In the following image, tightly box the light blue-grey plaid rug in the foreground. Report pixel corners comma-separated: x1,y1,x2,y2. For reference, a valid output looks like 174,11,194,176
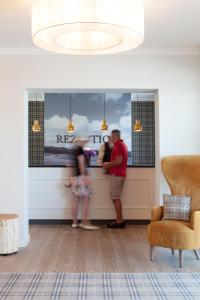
0,273,200,300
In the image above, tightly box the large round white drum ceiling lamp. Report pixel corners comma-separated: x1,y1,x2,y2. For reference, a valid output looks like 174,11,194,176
32,0,144,55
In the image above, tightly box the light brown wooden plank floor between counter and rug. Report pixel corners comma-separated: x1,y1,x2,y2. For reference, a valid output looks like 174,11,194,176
0,225,200,272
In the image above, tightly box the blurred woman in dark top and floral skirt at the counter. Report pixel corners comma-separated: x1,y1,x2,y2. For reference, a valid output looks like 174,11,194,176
71,136,99,230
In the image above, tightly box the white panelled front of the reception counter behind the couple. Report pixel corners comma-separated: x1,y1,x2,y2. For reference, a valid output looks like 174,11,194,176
29,167,155,220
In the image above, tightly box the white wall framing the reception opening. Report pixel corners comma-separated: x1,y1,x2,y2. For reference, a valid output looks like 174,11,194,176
0,55,200,244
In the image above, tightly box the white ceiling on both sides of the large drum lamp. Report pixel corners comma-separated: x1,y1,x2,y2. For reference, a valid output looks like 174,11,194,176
0,0,200,48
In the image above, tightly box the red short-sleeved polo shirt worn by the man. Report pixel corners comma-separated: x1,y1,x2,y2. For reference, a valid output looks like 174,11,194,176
110,140,128,177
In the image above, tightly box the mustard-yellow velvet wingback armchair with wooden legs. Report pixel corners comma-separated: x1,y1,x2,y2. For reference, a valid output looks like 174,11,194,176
147,155,200,268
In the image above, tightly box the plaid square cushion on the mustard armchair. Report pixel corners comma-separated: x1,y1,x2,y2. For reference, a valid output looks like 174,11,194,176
163,194,191,221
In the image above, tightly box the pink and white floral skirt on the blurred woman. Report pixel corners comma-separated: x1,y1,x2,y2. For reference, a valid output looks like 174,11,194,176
71,175,92,197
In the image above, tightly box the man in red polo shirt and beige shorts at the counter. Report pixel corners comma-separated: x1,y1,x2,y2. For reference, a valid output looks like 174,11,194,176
102,129,128,228
